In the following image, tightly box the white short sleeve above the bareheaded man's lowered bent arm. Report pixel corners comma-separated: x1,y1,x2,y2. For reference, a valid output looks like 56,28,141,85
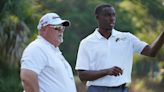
75,41,89,70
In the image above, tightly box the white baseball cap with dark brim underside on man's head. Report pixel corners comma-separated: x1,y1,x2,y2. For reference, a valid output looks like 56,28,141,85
37,13,70,30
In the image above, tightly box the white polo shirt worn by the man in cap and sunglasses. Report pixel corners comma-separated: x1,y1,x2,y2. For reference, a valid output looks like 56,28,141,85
21,36,76,92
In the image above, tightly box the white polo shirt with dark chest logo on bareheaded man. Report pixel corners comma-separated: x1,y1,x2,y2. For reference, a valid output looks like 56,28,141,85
75,29,147,87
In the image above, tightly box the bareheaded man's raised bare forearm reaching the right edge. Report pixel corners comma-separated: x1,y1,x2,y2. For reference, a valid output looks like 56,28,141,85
141,32,164,57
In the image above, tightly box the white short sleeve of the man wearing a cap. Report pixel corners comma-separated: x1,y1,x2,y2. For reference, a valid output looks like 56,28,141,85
21,46,46,74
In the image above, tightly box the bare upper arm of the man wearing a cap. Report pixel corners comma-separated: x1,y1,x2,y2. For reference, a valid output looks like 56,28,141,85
20,69,39,92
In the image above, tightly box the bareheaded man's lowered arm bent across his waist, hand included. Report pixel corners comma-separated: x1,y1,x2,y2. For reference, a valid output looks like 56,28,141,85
78,66,123,81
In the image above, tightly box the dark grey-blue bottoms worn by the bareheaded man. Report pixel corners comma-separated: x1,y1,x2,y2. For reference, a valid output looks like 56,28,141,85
87,85,128,92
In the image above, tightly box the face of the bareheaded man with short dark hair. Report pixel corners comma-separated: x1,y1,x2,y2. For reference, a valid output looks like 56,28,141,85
97,7,116,30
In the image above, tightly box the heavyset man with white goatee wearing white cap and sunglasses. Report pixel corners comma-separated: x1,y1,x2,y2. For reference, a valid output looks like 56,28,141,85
20,13,76,92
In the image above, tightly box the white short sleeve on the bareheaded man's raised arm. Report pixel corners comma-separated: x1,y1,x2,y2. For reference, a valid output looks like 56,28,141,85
129,33,148,54
